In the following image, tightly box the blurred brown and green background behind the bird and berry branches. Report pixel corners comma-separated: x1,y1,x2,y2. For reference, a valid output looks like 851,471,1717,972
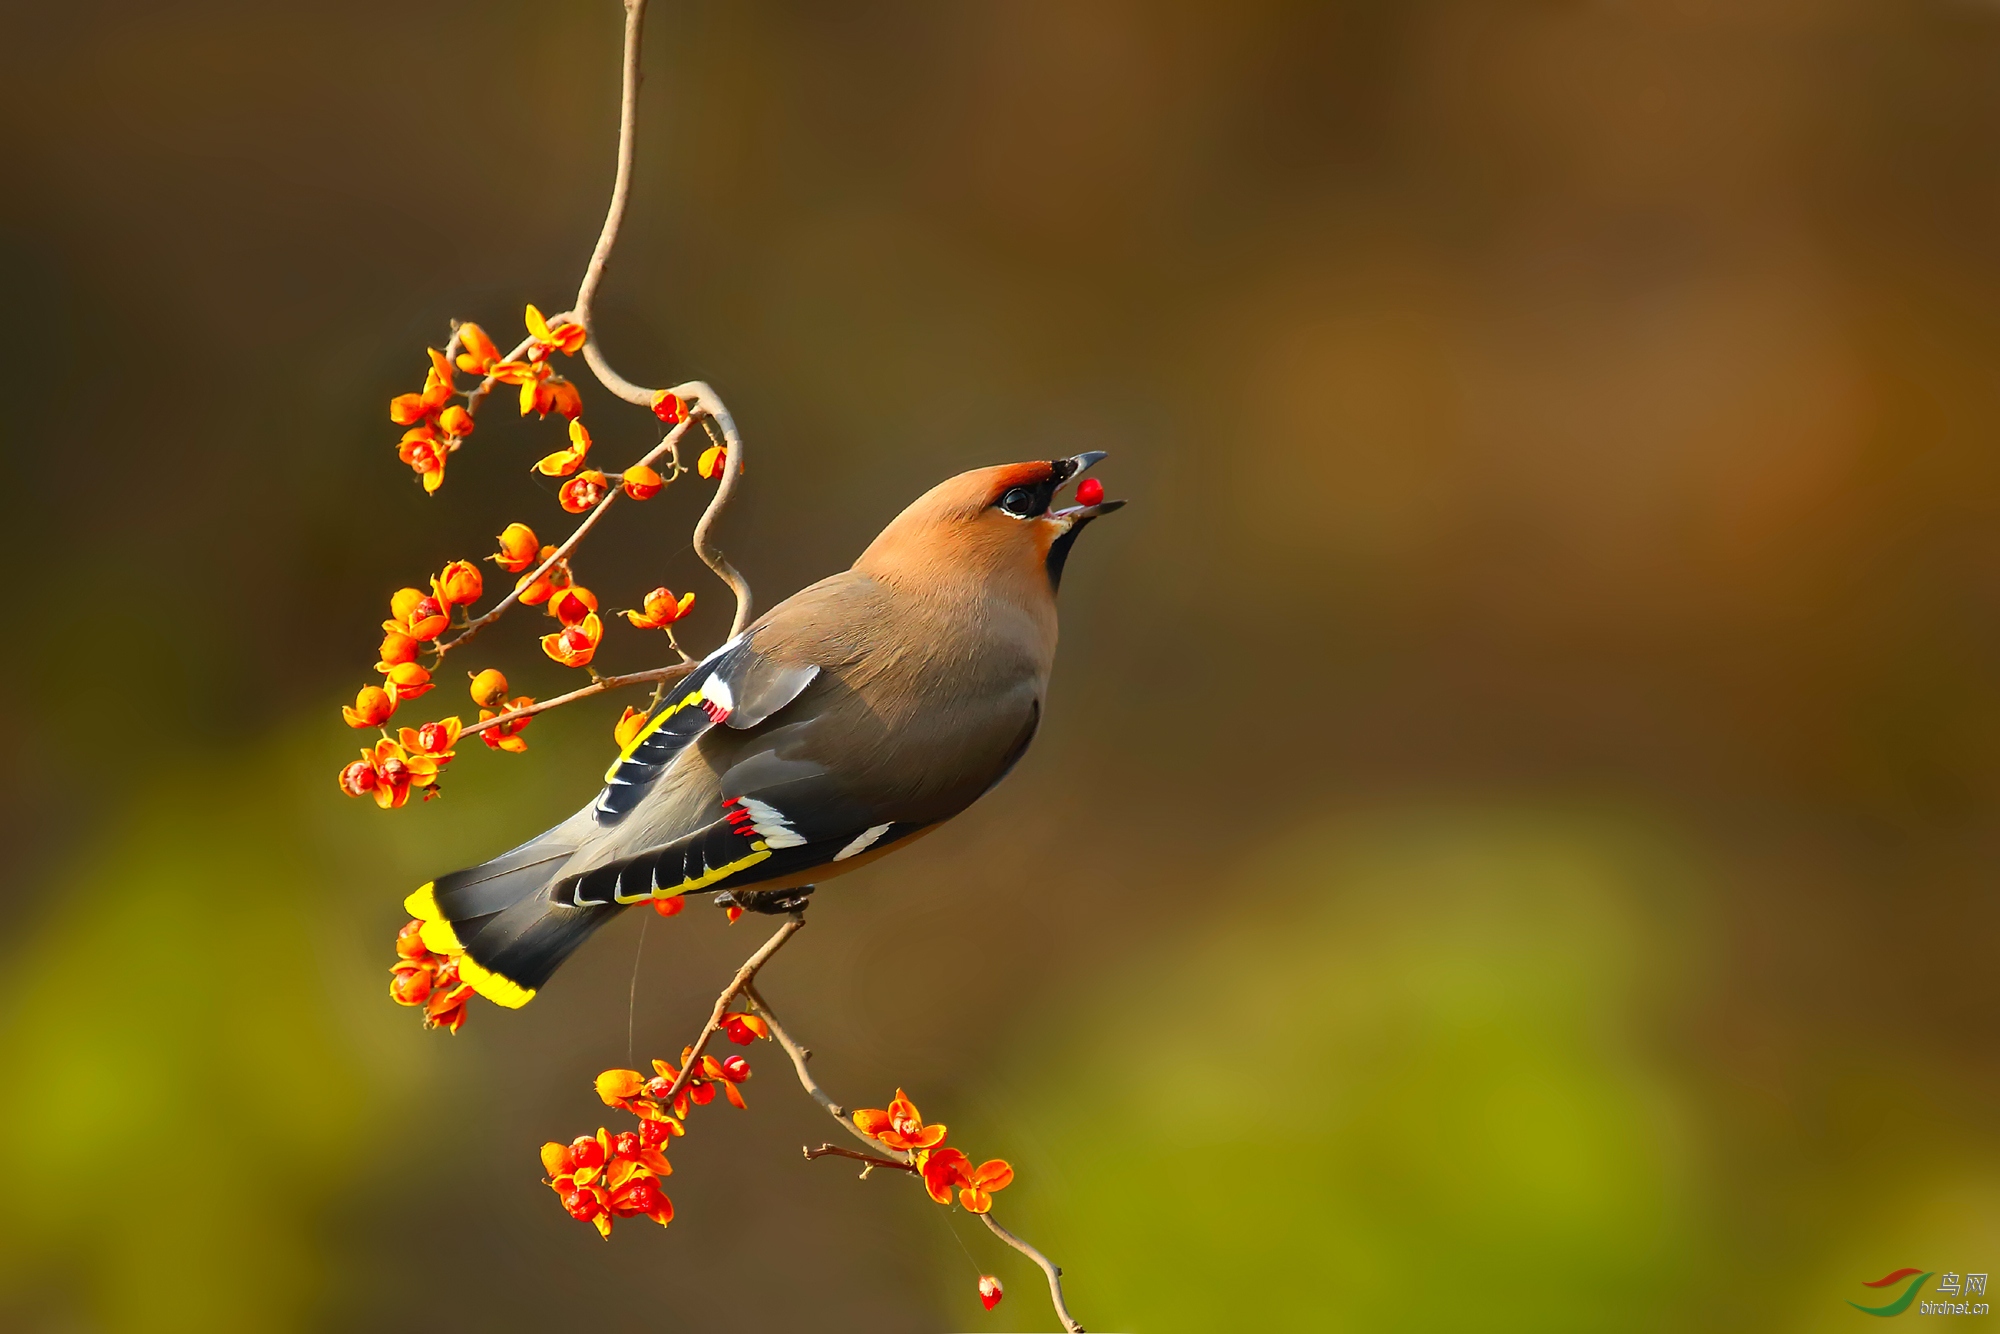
0,0,2000,1334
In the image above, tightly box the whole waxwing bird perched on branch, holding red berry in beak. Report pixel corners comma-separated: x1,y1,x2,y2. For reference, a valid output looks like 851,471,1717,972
404,450,1124,1008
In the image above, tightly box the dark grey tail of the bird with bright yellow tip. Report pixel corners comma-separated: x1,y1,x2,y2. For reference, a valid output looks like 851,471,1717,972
402,834,620,1008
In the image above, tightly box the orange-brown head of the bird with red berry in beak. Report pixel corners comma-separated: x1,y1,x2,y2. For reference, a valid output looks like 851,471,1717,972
854,450,1124,594
